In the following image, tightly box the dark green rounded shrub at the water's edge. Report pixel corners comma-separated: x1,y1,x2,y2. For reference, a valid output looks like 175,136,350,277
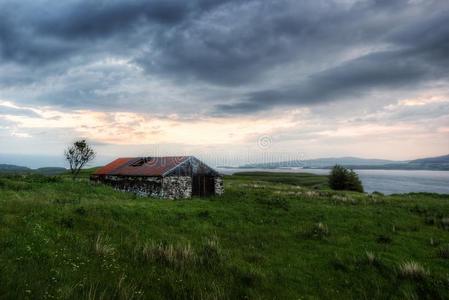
329,165,363,193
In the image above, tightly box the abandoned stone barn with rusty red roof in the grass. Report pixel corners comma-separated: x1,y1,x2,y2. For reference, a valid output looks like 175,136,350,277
91,156,224,199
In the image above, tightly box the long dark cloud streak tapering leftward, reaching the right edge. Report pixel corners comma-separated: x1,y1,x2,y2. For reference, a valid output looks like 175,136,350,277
217,51,436,113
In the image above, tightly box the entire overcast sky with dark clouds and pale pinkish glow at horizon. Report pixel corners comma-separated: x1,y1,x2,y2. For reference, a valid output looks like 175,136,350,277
0,0,449,168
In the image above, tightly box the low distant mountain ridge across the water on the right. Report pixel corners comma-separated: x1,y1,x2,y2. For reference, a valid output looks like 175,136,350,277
239,155,449,170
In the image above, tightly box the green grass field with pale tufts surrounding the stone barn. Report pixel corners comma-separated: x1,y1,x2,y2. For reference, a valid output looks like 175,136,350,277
0,172,449,299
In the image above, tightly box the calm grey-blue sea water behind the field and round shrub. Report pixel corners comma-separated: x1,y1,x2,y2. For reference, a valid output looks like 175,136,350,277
218,169,449,194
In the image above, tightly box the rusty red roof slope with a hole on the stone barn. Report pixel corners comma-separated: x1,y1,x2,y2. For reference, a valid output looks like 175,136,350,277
94,156,190,176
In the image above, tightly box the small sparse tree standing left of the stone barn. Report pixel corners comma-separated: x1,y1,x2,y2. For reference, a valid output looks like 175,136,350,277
64,140,95,179
